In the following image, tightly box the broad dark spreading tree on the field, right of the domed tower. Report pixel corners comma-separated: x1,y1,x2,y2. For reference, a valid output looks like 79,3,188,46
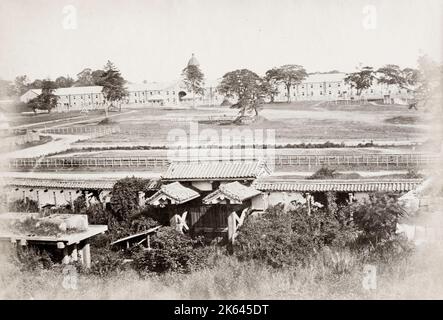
218,69,269,118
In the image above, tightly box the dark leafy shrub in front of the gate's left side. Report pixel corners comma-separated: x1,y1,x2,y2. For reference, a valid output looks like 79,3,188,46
134,227,210,273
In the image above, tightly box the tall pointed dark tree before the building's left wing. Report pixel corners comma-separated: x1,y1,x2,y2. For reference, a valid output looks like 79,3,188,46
100,60,128,115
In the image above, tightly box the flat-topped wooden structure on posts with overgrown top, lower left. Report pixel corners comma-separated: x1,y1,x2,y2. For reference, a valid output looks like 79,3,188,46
0,213,108,268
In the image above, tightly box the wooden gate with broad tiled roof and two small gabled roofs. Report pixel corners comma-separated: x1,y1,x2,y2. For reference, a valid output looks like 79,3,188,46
146,161,270,239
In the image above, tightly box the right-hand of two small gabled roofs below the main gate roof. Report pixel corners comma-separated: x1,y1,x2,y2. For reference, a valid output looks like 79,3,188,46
203,181,261,204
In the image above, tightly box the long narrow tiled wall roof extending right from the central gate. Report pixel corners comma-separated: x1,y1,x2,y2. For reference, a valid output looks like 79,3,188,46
253,179,422,192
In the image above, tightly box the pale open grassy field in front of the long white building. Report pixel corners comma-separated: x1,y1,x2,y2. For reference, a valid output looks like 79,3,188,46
80,102,429,144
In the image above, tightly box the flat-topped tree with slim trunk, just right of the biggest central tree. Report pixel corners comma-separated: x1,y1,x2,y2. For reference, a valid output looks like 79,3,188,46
266,64,308,102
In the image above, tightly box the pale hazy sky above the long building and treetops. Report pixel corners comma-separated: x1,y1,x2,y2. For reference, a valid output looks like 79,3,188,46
0,0,443,82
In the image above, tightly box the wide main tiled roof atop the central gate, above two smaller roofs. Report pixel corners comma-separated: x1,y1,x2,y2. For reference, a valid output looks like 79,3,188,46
162,161,270,181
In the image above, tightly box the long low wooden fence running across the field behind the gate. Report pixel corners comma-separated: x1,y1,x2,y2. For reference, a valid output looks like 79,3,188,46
4,154,440,170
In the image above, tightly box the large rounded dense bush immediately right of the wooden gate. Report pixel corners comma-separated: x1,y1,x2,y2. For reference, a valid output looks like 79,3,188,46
234,205,356,267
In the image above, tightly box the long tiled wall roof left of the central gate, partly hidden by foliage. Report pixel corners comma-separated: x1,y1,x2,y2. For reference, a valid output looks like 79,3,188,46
2,178,160,190
